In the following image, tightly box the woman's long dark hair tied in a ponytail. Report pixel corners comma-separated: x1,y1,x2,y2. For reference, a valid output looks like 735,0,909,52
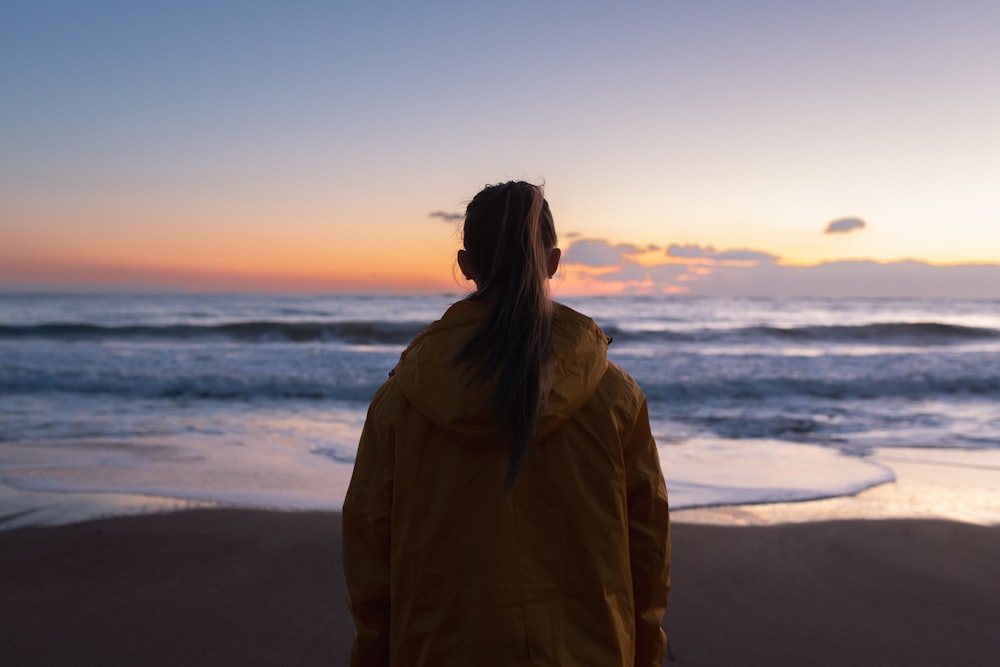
455,181,556,489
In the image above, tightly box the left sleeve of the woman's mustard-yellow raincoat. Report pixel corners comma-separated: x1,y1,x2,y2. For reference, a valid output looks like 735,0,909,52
343,386,394,667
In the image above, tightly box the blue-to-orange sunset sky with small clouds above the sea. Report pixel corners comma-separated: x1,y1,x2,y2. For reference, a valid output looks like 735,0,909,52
0,0,1000,298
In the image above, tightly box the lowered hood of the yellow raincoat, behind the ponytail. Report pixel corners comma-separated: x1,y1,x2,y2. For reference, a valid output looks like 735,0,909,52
390,300,610,444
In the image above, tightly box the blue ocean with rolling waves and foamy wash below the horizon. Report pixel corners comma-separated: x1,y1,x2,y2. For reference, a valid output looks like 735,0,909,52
0,294,1000,527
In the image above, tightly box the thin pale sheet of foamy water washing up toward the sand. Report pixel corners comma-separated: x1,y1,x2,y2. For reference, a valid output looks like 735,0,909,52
0,434,892,519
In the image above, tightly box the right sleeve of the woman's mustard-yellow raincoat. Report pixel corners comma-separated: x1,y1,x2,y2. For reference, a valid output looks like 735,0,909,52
625,397,670,667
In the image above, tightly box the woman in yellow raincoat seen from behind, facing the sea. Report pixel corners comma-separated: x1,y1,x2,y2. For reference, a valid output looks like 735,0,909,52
343,182,670,667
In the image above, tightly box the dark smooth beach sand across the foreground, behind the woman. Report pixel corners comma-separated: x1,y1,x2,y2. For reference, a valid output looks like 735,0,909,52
0,509,1000,666
